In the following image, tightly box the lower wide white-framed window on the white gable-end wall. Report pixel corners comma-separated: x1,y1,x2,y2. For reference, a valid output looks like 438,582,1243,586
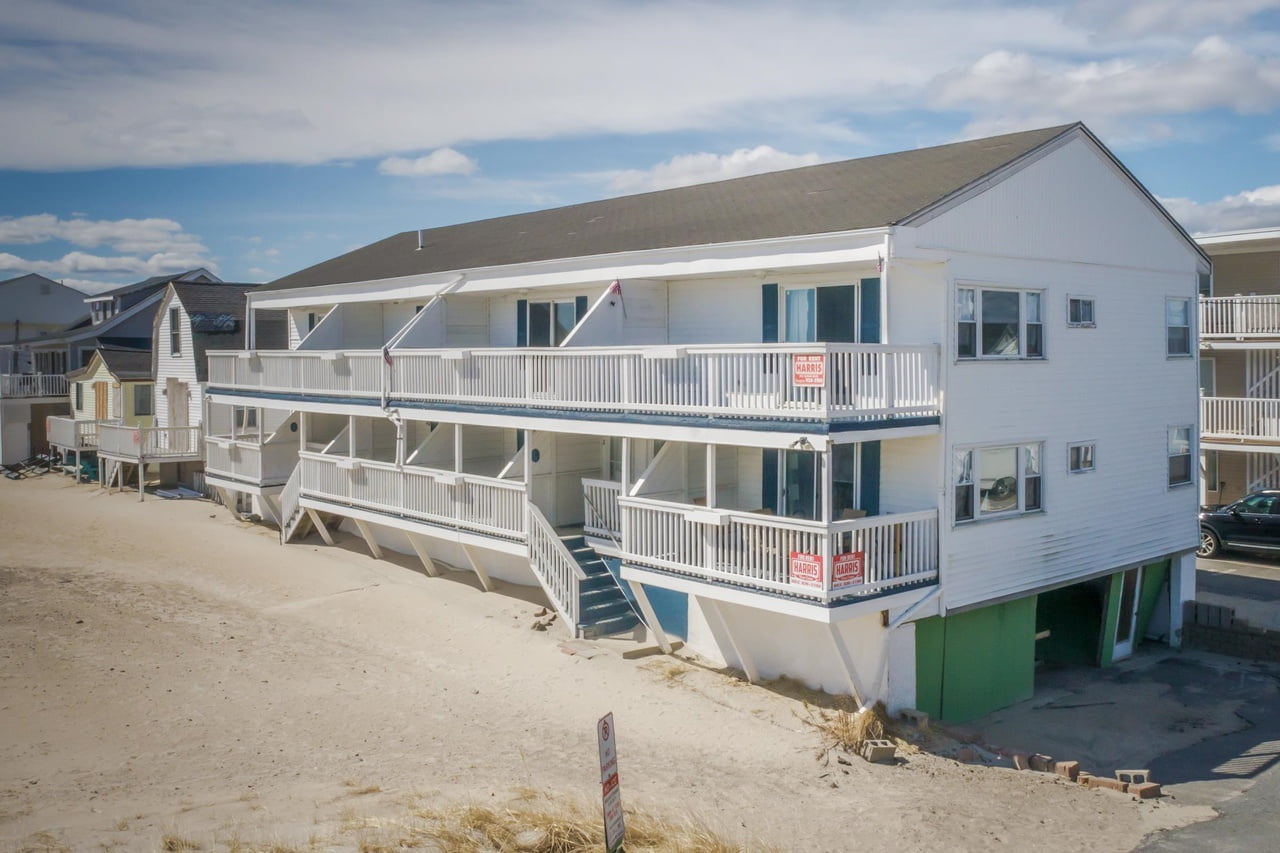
955,443,1044,521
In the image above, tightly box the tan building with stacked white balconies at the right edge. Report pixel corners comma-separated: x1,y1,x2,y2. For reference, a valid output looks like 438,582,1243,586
1198,228,1280,514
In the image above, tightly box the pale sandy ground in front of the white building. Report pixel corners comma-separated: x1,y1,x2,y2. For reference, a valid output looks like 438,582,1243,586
0,476,1207,850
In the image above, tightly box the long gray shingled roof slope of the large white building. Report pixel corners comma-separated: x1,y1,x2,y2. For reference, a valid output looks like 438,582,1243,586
262,124,1079,291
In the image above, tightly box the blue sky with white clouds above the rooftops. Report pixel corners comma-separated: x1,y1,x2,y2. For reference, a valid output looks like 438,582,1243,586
0,0,1280,289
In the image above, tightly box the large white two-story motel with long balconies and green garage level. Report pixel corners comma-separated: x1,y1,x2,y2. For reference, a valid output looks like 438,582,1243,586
206,124,1210,720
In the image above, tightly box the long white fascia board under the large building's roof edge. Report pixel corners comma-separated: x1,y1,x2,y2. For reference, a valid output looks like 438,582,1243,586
248,228,888,309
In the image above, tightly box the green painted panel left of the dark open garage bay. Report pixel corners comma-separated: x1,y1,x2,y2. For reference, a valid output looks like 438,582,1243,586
915,596,1036,722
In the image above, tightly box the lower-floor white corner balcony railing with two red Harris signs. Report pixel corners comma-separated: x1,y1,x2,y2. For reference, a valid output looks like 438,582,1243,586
618,497,938,602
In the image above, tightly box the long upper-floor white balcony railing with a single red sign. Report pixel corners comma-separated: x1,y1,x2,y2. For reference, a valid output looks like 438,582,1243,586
209,343,940,420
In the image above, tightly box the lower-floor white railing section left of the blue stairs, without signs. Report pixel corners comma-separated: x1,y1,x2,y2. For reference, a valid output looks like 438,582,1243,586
298,452,527,540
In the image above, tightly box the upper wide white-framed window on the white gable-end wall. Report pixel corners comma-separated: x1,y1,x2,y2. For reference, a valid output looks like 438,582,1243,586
956,287,1044,359
